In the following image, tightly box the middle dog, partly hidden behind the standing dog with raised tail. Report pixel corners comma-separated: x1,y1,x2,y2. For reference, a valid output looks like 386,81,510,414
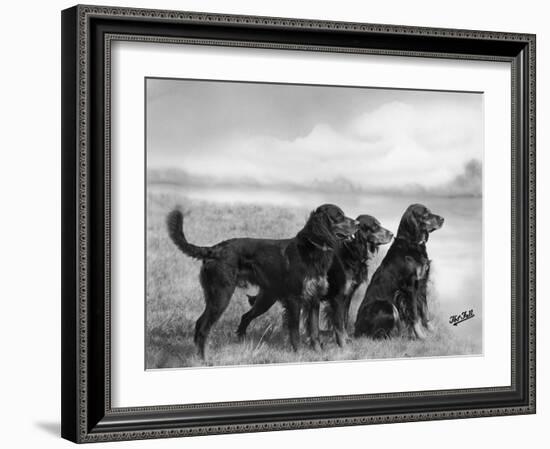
245,215,393,346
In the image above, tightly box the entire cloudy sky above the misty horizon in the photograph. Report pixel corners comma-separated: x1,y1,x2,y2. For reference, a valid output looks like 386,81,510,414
146,79,483,193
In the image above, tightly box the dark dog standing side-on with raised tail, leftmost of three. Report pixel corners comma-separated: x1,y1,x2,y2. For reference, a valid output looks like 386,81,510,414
167,204,357,358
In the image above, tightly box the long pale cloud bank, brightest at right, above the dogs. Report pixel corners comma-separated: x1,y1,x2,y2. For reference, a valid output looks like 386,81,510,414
152,102,482,189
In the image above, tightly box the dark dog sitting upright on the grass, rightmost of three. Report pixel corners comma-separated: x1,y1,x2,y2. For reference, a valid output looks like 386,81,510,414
355,204,444,338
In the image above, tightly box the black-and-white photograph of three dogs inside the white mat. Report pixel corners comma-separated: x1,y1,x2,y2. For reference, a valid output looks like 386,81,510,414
145,78,484,369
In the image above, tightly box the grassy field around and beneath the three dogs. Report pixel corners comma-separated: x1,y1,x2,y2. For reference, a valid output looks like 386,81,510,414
145,187,481,369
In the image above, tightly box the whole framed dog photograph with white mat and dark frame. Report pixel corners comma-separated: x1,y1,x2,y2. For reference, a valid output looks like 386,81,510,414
62,6,535,442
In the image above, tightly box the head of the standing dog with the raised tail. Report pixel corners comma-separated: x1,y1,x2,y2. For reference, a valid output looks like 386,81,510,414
300,204,358,248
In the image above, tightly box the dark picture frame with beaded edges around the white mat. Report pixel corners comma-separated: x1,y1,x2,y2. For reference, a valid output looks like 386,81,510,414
62,6,535,442
